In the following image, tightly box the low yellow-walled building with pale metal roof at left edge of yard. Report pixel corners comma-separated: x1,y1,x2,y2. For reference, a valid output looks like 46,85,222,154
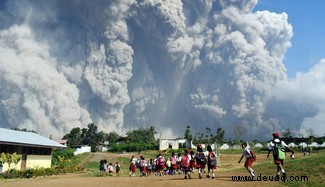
0,128,66,171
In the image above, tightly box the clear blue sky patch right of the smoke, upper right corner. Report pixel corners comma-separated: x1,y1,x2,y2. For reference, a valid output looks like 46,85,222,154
254,0,325,77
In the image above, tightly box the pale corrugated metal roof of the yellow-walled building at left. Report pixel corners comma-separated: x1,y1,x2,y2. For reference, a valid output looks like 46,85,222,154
0,128,66,148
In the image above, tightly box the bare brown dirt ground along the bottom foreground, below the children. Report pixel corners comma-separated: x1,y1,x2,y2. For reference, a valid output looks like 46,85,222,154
0,173,280,187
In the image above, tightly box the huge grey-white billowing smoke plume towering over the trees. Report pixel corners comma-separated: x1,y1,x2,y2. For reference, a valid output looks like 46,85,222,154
0,0,318,140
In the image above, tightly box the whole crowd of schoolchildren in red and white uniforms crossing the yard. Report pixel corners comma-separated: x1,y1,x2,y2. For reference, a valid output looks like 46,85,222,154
100,132,294,179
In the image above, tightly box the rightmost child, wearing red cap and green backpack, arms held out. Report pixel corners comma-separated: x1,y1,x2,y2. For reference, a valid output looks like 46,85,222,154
267,132,295,178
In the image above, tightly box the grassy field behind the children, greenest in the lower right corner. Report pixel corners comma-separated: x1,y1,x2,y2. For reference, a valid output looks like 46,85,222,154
78,151,325,186
